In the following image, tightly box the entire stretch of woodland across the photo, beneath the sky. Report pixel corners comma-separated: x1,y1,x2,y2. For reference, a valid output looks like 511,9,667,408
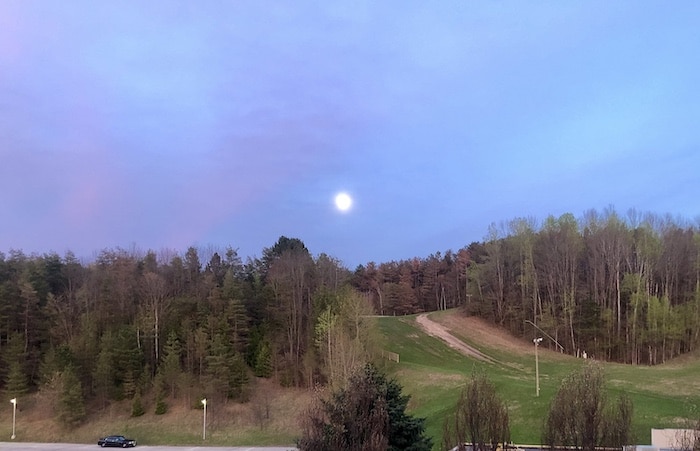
0,209,700,422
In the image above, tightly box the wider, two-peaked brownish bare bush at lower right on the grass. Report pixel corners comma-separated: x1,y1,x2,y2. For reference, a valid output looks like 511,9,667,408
542,362,632,451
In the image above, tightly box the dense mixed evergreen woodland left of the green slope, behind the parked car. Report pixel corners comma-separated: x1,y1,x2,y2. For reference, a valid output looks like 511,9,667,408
0,237,376,424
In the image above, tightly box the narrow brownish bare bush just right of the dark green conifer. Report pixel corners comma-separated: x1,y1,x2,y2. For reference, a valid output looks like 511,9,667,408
443,373,510,451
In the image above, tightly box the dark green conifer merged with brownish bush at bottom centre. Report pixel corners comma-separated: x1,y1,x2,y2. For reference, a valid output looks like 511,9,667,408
297,364,432,451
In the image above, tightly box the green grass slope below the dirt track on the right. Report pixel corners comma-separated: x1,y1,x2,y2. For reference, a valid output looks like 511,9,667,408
379,311,700,449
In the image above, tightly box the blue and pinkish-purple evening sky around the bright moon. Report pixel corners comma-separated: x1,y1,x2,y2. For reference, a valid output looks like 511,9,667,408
0,0,700,269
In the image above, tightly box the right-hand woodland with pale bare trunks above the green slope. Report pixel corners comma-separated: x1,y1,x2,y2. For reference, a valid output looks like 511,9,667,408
353,208,700,365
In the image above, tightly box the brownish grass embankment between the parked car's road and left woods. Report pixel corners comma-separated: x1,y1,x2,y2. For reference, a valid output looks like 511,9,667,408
0,379,312,446
